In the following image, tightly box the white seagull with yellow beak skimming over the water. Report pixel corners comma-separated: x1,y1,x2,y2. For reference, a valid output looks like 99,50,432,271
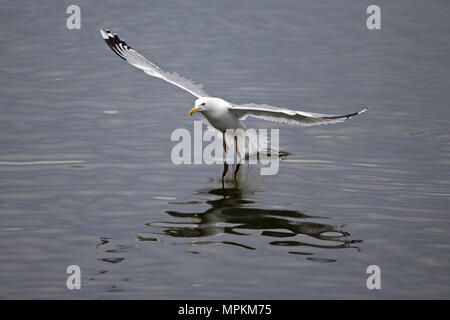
100,29,370,158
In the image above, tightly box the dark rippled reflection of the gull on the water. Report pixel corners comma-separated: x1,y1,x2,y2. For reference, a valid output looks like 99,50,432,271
147,165,359,254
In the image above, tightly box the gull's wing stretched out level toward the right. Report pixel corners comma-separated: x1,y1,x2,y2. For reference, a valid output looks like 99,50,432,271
229,103,370,126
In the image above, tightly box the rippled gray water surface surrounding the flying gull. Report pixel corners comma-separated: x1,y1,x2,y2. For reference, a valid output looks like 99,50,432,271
0,0,450,299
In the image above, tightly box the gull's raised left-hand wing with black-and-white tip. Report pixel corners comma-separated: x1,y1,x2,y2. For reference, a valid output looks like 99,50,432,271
100,29,208,98
